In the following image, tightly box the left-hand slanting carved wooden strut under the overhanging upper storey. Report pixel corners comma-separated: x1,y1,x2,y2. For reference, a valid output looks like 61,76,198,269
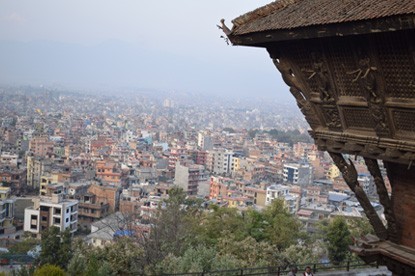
329,151,388,240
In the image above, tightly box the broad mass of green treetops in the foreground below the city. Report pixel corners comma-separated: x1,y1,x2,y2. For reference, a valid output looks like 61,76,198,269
61,188,321,276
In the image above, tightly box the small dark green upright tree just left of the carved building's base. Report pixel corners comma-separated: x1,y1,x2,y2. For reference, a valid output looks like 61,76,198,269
326,216,351,264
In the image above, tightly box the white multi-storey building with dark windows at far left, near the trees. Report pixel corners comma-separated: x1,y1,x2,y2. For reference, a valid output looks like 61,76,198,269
23,194,78,237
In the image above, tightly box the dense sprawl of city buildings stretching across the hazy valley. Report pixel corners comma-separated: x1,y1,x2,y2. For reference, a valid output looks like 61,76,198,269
0,87,383,275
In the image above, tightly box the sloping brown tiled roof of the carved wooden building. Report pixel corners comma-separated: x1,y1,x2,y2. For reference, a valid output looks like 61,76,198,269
232,0,415,35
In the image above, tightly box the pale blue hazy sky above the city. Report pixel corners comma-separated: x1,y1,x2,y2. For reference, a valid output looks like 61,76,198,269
0,0,290,99
